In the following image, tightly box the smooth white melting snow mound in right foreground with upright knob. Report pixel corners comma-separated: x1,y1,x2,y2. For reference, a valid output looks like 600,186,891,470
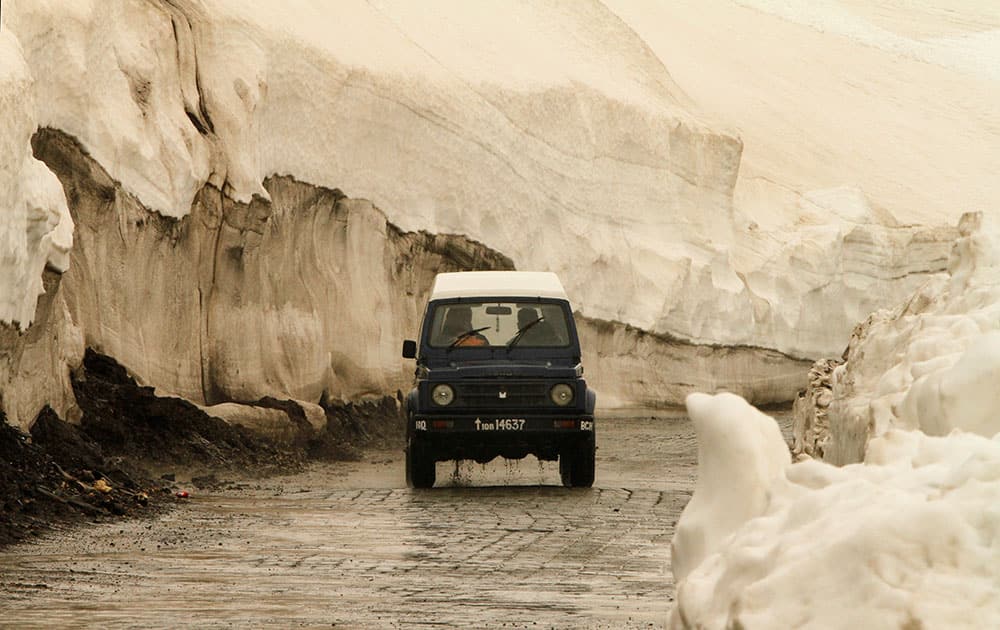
671,395,1000,630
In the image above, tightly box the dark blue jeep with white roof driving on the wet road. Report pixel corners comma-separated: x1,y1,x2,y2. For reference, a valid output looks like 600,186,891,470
403,271,597,488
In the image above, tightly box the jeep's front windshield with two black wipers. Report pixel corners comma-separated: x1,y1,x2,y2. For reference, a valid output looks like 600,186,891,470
430,301,570,348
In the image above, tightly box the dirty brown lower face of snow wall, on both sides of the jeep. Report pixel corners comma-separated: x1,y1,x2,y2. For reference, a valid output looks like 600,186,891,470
3,129,804,427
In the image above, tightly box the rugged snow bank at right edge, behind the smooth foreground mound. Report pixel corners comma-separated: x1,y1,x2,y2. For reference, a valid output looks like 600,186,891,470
795,212,1000,464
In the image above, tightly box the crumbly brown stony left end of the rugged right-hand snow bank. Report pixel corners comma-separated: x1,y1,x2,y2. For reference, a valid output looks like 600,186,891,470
792,359,844,461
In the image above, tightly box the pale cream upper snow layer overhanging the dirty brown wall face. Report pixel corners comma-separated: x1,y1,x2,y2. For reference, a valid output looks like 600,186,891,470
4,0,742,346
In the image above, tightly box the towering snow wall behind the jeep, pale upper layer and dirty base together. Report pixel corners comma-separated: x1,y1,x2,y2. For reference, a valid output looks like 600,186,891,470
0,0,968,426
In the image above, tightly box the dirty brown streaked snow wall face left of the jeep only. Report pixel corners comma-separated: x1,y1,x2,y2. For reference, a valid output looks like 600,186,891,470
3,130,512,424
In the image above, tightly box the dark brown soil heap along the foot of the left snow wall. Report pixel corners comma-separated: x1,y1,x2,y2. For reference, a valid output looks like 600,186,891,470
0,349,403,547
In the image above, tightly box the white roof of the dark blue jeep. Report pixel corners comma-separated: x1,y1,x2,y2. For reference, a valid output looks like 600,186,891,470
430,271,569,301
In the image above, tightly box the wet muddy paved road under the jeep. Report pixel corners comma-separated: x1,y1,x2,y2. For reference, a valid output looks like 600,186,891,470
0,412,772,628
